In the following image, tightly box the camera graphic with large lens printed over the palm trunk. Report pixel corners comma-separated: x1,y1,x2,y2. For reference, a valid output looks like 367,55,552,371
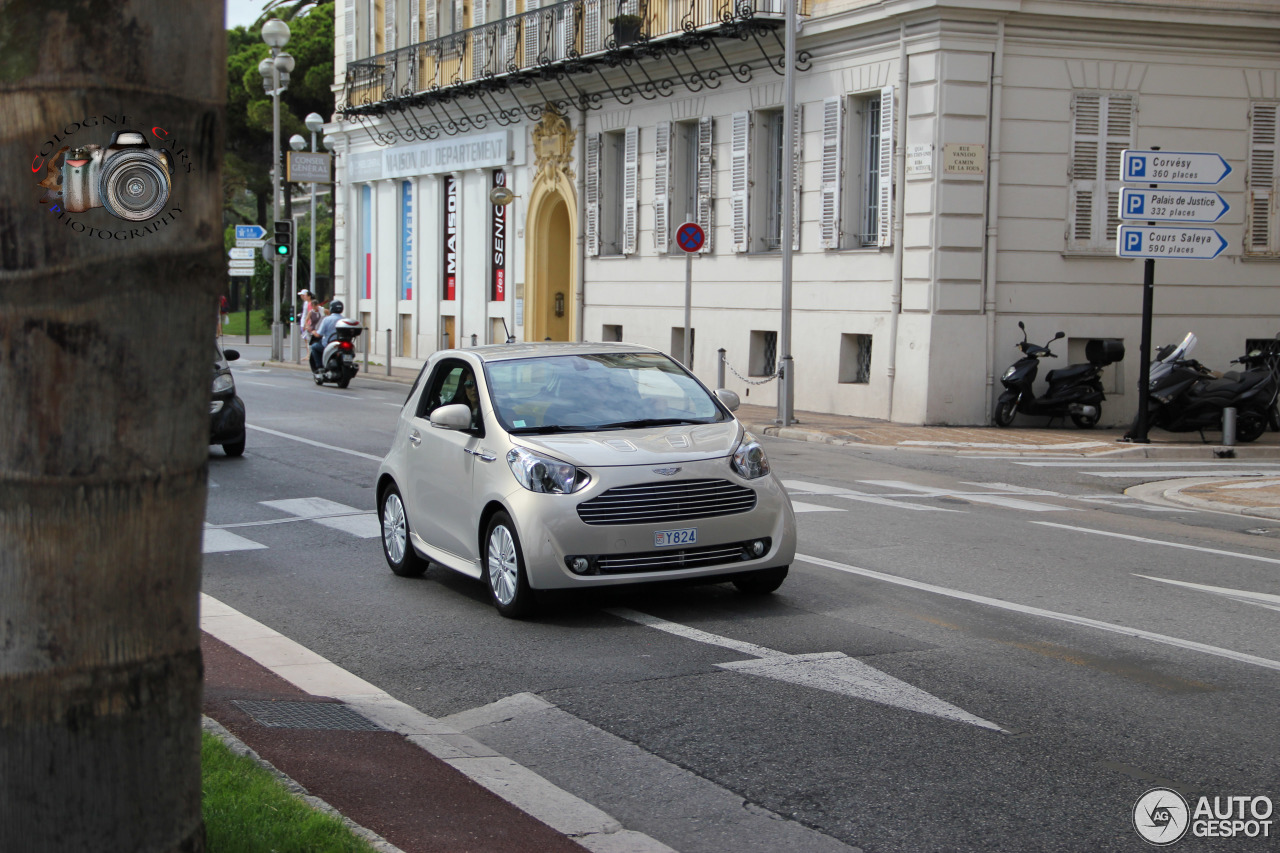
49,131,173,222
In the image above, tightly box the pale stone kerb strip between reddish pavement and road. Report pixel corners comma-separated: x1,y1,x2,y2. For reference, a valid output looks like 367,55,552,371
200,593,675,853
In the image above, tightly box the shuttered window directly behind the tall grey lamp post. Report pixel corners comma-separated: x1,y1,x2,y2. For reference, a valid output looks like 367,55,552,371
730,104,804,252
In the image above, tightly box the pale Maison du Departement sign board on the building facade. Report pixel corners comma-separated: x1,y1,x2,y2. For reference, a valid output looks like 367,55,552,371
347,131,524,183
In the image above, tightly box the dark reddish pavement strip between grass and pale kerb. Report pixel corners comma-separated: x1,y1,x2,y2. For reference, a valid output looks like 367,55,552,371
201,634,585,853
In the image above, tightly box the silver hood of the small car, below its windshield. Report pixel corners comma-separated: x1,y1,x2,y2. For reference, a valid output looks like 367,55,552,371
512,420,741,467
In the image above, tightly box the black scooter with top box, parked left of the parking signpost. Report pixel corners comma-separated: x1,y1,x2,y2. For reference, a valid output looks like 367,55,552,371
995,320,1124,429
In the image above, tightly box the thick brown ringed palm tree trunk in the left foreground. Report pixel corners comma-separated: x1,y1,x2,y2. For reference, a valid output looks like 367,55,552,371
0,0,227,853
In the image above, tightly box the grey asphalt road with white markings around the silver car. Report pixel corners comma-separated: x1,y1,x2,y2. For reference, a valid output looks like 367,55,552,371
204,358,1280,853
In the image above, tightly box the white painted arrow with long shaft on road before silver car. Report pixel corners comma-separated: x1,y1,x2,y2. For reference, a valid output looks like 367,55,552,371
605,607,1004,731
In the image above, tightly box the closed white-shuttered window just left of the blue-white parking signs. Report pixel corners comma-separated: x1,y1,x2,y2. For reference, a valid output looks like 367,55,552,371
1066,92,1137,251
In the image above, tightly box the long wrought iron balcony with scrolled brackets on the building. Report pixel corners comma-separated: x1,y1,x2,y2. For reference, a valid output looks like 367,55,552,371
338,0,809,145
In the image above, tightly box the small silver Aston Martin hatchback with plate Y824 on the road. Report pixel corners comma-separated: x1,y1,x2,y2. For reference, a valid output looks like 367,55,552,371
378,343,796,616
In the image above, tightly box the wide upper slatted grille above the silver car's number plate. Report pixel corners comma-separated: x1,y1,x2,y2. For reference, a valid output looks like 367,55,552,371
577,480,755,524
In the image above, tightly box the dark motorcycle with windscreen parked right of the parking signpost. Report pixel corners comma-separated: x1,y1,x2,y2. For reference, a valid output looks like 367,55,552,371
1129,333,1280,442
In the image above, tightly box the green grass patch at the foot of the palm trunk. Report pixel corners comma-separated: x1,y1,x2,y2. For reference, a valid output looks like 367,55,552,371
200,731,374,853
